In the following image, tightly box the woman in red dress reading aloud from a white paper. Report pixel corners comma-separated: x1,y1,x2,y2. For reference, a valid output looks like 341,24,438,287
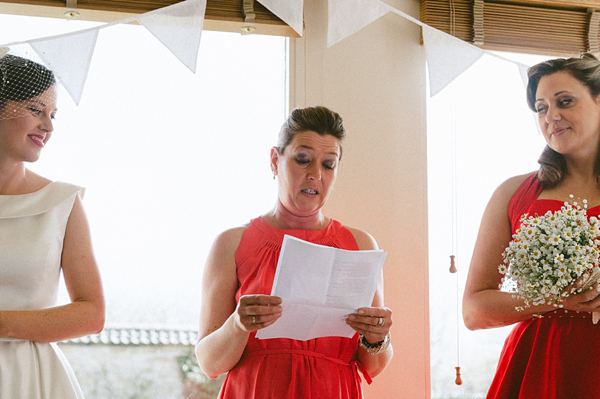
196,107,392,399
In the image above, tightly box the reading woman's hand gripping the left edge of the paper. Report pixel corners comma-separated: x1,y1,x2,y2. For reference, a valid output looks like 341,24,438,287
234,295,283,332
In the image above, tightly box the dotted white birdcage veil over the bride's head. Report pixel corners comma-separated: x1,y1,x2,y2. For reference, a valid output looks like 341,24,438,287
0,47,56,119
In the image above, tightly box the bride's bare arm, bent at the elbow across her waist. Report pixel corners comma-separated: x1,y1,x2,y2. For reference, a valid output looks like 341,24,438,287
0,196,104,342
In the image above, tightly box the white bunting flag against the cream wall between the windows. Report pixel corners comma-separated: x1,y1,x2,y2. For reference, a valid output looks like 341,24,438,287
327,0,393,47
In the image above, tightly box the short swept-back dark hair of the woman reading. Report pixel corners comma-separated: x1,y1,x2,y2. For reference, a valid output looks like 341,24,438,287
277,106,346,159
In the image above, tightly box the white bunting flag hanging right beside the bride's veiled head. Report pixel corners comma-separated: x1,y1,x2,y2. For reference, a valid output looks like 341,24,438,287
29,29,99,105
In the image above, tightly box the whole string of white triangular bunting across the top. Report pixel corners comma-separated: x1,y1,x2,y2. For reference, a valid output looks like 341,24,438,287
0,0,544,104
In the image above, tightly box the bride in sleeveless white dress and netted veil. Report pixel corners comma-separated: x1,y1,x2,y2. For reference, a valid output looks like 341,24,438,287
0,54,104,399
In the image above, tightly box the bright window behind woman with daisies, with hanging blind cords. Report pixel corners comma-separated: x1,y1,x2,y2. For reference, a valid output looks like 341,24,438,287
427,53,552,398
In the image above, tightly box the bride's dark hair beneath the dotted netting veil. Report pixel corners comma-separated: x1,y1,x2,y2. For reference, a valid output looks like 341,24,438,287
0,54,56,109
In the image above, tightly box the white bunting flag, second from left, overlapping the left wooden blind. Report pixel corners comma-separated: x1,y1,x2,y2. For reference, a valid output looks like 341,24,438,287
138,0,206,72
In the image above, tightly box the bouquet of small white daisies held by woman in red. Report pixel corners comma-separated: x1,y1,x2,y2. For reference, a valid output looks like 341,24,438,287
498,195,600,324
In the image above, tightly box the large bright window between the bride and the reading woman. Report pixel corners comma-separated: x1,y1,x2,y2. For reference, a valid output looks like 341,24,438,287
0,11,287,399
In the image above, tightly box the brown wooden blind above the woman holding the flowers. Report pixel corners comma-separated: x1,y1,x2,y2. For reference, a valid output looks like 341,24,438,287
421,0,600,56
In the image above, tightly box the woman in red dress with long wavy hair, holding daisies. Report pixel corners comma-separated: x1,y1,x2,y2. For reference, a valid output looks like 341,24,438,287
463,54,600,399
